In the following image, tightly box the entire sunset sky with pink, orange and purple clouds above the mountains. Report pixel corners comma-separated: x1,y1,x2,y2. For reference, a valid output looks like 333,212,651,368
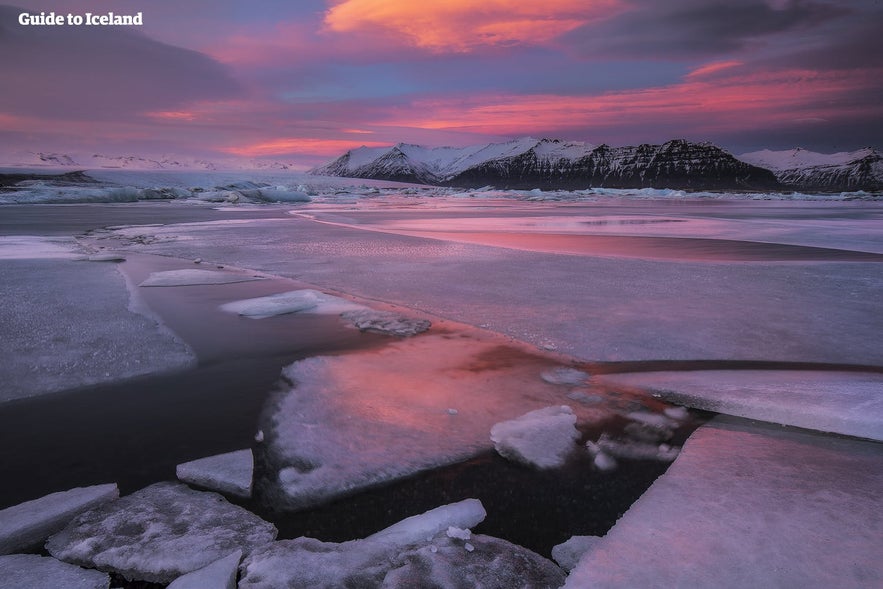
0,0,883,168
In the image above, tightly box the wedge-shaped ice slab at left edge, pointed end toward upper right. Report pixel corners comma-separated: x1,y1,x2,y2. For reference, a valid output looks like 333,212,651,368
0,484,119,554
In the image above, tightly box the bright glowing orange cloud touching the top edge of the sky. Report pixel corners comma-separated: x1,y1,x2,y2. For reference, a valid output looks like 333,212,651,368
325,0,621,53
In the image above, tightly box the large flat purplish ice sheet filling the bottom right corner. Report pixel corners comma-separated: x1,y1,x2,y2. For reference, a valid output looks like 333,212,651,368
565,418,883,589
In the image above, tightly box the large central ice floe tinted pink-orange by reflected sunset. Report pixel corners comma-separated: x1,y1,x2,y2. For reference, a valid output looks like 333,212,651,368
256,333,612,508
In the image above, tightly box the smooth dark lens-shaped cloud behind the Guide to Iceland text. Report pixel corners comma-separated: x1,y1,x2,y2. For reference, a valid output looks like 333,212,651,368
0,5,241,120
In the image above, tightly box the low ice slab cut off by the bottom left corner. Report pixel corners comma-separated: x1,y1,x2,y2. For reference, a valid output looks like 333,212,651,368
0,554,110,589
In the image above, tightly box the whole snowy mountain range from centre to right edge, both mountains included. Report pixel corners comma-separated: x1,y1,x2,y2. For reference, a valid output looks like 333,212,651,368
310,137,883,191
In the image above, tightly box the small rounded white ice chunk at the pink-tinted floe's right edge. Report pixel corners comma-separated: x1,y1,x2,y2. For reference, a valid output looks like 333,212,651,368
491,405,579,468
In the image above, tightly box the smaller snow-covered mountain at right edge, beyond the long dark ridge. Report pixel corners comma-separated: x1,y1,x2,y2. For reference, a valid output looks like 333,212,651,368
739,147,883,191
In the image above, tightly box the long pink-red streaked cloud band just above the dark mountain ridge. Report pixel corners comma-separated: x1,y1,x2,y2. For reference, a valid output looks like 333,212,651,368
372,70,881,136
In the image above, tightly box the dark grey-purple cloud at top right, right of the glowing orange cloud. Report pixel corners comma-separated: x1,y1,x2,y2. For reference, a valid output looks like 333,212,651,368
563,0,848,59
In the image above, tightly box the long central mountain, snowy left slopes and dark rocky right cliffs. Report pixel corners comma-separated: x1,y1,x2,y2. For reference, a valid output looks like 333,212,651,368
311,137,780,189
